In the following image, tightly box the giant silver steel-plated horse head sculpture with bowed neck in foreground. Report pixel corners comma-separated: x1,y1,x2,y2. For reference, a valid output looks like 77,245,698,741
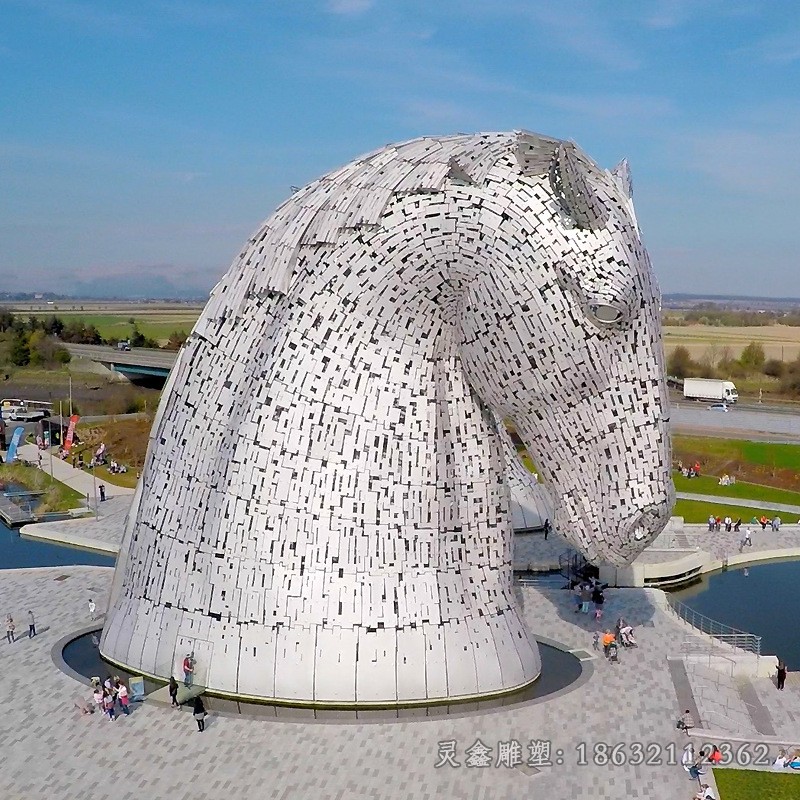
101,133,672,705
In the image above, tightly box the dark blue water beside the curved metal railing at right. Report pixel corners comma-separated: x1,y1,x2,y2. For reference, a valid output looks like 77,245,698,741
672,561,800,671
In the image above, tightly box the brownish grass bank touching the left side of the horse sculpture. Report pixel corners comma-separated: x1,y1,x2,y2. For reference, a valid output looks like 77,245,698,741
72,418,153,489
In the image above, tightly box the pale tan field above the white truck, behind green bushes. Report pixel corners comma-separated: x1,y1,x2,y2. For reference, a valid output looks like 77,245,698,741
664,325,800,361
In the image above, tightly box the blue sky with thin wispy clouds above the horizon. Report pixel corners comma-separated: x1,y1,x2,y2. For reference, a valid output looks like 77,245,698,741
0,0,800,297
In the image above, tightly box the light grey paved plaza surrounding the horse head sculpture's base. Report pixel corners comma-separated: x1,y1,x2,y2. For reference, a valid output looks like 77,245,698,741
0,454,800,800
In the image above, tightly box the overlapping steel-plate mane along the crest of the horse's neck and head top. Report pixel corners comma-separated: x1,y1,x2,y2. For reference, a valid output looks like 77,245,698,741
206,131,630,328
